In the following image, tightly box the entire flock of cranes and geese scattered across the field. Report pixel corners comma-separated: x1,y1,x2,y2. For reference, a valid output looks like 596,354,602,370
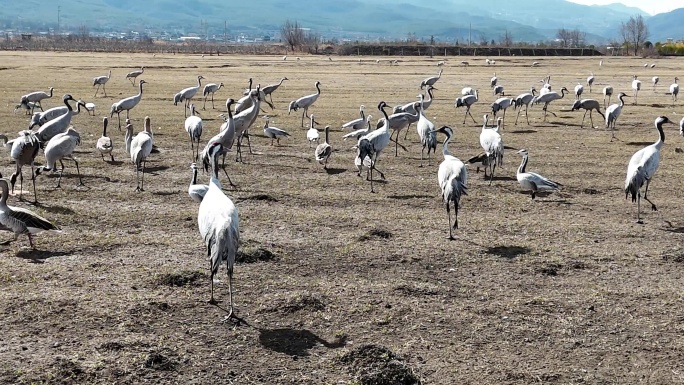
0,59,684,319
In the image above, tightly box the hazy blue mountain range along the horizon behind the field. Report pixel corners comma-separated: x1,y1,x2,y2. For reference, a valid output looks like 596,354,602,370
5,0,684,43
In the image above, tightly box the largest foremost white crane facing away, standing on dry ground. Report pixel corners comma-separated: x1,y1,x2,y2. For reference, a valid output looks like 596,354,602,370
197,143,240,319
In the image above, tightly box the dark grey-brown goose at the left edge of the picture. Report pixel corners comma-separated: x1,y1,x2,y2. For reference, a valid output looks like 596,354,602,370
0,179,60,249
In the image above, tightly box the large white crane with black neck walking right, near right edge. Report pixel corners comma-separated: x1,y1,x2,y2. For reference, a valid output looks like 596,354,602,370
625,116,672,223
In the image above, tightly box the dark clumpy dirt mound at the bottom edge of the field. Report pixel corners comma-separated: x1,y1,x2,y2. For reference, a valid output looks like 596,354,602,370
340,345,421,385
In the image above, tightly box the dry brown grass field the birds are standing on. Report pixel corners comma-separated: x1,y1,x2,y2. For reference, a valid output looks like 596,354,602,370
0,52,684,384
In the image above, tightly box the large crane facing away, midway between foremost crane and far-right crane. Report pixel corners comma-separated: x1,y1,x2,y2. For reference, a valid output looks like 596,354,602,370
437,126,468,240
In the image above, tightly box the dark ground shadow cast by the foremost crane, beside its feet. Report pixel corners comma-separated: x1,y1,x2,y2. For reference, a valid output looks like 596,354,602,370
259,328,347,357
